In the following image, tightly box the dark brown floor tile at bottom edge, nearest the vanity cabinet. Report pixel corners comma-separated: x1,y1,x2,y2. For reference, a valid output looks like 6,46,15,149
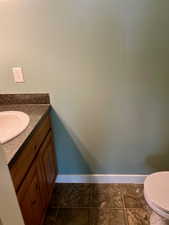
44,208,89,225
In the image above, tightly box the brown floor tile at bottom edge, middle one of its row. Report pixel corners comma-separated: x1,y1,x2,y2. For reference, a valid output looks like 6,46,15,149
89,208,126,225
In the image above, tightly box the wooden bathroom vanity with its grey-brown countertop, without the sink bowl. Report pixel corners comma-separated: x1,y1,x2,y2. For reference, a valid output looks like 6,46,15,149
0,94,57,225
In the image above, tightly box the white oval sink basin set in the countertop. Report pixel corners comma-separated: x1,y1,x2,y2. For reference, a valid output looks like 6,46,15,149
0,111,30,144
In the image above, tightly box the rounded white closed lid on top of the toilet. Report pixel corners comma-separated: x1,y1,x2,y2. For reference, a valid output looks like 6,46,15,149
144,171,169,212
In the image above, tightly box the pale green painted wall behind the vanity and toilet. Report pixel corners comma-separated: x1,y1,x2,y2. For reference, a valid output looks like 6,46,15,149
0,0,169,174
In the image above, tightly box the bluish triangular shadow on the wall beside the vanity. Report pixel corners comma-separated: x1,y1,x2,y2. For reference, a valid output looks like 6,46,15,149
51,108,97,174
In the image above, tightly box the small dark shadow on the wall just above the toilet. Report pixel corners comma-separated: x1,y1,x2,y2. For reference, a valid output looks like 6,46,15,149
146,144,169,171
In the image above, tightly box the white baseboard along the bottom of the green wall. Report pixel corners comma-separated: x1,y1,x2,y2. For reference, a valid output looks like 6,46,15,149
56,174,147,184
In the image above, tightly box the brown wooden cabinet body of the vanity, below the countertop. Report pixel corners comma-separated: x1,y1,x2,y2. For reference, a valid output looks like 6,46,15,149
10,115,57,225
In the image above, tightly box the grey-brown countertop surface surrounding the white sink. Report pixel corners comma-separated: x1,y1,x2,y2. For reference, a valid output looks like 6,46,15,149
0,104,50,165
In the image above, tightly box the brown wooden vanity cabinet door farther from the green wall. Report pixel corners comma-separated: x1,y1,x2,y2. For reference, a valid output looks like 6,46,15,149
17,162,43,225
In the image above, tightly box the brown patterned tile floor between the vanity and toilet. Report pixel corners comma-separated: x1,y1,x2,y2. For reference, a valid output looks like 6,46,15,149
44,184,151,225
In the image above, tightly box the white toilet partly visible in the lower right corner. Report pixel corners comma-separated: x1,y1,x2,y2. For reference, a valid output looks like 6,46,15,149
144,172,169,225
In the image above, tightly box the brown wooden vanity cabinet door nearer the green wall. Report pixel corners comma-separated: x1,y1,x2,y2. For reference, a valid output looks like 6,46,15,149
41,132,57,201
